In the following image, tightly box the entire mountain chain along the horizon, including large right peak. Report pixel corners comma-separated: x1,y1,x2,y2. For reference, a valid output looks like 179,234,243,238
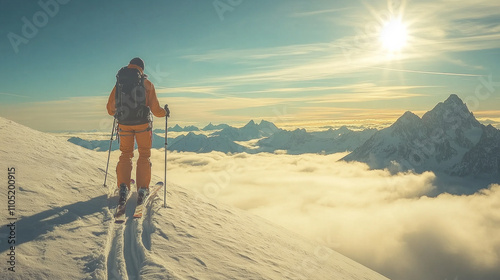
68,94,500,178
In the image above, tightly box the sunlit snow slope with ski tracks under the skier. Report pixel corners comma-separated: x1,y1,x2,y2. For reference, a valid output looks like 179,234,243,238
0,118,387,280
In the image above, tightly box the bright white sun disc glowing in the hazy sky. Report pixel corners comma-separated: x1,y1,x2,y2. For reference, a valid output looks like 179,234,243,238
379,19,408,52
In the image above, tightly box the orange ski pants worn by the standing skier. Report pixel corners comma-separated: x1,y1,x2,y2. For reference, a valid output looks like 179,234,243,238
116,124,152,189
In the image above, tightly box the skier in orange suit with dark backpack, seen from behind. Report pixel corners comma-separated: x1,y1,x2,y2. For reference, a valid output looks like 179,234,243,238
106,57,170,205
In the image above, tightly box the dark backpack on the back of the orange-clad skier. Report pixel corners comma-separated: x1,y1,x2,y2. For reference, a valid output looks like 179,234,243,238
115,67,150,125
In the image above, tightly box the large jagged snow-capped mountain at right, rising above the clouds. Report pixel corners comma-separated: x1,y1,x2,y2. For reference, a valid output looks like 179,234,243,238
342,94,500,176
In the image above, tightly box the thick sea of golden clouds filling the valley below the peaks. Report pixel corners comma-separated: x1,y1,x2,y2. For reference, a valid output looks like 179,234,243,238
149,151,500,280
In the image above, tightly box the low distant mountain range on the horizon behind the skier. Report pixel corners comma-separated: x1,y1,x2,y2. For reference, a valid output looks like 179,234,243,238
68,120,376,154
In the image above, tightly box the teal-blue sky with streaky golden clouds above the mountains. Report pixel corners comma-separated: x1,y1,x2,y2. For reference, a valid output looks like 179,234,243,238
0,0,500,131
